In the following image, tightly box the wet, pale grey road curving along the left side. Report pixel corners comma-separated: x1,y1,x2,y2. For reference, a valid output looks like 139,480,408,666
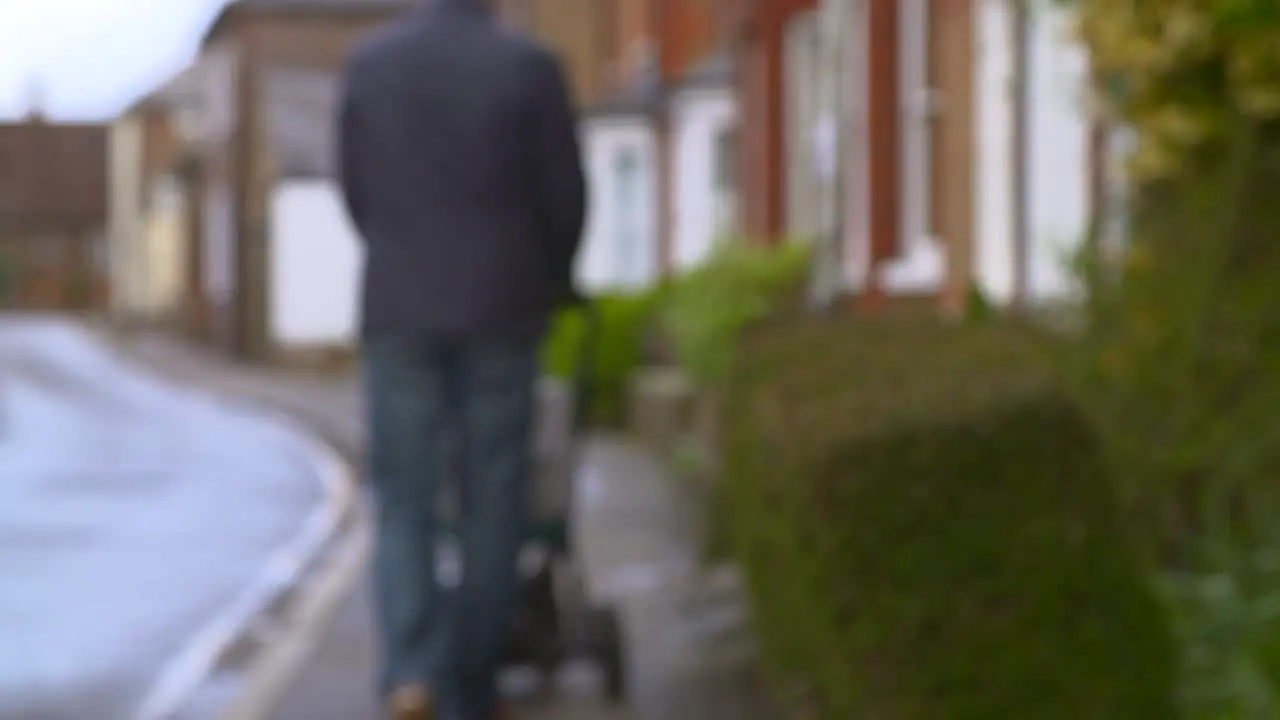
0,318,320,720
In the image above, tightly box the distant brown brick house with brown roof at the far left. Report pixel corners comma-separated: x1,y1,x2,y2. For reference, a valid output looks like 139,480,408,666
0,114,109,311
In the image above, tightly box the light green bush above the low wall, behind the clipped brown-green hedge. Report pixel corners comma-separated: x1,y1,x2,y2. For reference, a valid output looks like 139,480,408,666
662,240,812,386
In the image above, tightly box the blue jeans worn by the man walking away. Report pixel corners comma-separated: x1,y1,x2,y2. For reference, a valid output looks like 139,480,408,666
364,338,538,720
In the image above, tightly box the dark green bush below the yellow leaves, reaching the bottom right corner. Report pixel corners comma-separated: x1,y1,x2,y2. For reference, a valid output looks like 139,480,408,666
1075,123,1280,720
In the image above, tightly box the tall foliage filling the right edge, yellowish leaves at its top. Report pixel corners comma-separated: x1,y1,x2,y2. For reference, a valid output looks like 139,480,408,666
1071,0,1280,707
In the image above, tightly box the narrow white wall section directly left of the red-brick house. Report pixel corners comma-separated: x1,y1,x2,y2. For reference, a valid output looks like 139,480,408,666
672,88,739,268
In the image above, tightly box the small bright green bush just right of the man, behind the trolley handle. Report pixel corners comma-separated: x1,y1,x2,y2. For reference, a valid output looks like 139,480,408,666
541,290,660,425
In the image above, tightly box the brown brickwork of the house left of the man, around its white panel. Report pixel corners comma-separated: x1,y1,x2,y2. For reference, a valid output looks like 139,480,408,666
187,0,413,359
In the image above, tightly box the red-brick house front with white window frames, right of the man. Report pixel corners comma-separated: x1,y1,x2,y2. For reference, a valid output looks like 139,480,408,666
733,0,1096,310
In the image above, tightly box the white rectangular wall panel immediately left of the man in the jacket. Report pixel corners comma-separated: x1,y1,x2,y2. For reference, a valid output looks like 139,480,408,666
268,181,364,348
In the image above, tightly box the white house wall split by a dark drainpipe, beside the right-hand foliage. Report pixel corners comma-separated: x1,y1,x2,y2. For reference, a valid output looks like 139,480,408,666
975,0,1089,302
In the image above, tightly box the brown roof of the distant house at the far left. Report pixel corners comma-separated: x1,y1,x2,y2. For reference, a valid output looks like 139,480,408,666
0,119,108,222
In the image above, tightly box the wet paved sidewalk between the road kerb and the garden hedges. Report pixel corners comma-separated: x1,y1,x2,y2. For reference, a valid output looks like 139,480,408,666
120,337,777,720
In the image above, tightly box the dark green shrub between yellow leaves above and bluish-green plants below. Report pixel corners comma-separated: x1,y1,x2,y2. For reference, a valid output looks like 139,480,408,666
1082,127,1280,550
